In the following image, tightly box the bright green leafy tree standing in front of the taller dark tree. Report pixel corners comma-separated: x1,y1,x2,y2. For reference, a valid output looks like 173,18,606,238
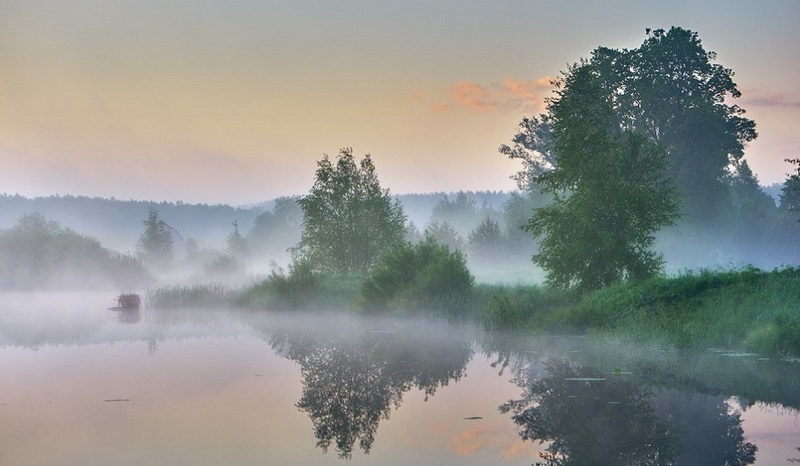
526,63,678,289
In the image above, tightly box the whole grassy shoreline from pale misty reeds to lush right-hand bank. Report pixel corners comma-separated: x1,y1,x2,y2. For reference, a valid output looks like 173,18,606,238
148,268,800,356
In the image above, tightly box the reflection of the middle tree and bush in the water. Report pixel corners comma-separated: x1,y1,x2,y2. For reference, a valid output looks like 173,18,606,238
270,316,472,458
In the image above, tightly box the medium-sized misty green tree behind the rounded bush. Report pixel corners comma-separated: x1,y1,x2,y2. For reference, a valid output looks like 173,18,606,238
294,148,406,274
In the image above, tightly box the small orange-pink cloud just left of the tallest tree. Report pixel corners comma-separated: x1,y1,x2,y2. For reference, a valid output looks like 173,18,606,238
440,76,553,113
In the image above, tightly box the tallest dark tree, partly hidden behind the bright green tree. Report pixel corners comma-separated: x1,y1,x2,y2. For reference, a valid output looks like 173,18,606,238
500,27,757,223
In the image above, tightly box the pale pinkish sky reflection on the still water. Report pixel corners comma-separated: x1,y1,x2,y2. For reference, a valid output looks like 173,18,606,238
0,294,800,465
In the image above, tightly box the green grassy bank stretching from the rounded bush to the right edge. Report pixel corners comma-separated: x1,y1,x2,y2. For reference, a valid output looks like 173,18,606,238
484,268,800,356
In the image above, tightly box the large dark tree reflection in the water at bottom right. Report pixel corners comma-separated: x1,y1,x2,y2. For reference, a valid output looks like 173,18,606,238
500,359,757,466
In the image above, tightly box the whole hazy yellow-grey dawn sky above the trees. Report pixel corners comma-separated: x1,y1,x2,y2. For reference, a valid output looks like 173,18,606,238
0,0,800,205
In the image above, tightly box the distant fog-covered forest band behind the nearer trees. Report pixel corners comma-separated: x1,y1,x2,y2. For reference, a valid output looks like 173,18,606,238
0,176,800,288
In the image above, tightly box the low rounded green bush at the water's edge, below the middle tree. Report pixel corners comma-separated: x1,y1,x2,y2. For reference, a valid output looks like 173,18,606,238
361,236,474,311
